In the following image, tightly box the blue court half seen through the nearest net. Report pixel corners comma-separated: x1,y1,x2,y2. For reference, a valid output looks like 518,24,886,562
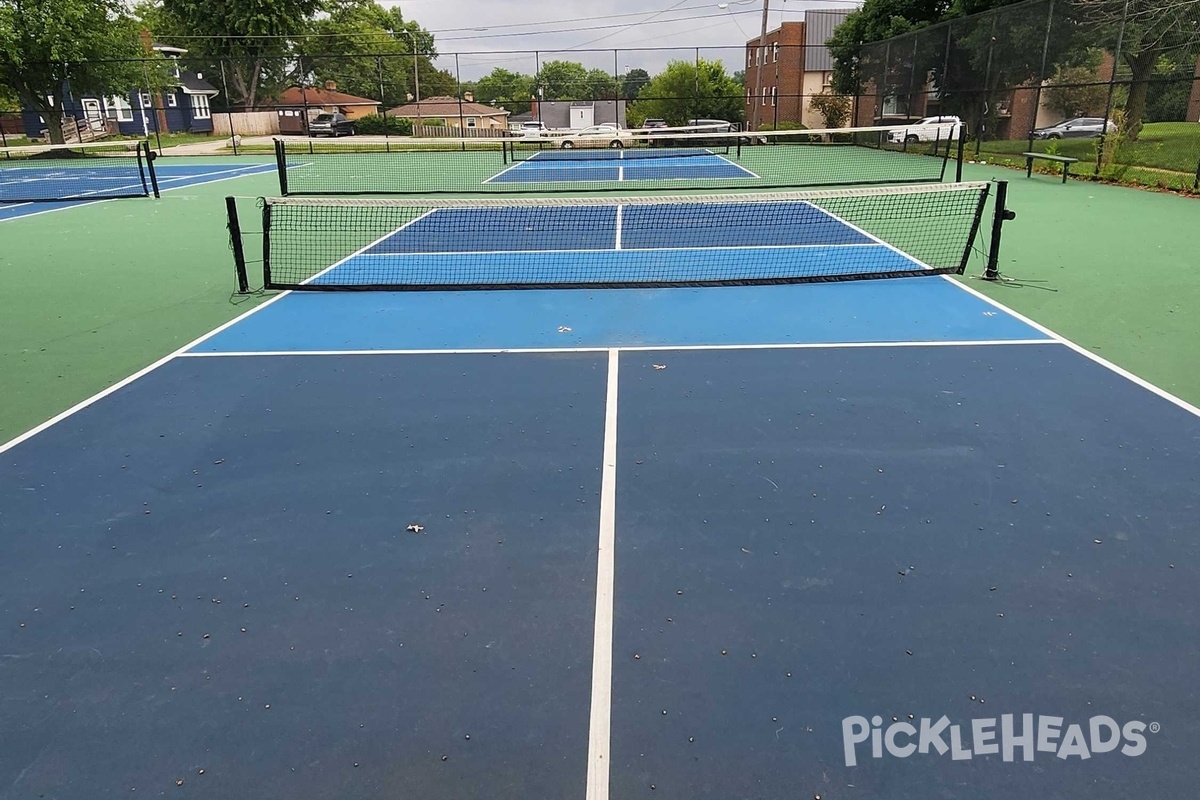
310,201,929,285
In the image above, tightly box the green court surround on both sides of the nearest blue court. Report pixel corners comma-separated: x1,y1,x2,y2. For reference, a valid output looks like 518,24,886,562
0,155,1200,441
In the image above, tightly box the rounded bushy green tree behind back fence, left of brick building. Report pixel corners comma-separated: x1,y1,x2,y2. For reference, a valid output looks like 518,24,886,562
630,59,744,126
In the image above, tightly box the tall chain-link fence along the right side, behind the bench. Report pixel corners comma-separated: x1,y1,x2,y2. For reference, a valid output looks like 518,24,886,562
853,0,1200,191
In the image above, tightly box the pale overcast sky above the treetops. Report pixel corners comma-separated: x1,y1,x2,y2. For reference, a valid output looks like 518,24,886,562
380,0,859,80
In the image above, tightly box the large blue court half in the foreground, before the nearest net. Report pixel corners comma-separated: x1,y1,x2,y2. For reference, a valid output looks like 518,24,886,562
0,272,1200,800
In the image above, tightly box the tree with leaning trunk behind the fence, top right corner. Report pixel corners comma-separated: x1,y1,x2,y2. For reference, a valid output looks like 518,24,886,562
1076,0,1200,142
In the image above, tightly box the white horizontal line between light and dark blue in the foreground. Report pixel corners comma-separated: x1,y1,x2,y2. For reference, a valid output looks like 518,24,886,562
179,338,1057,359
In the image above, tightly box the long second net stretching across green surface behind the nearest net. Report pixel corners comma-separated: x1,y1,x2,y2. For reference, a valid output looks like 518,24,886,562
275,125,961,196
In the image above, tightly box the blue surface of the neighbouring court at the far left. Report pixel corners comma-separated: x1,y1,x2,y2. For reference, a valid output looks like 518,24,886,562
0,158,275,222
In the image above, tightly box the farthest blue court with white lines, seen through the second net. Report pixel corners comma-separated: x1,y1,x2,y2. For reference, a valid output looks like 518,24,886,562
484,149,758,184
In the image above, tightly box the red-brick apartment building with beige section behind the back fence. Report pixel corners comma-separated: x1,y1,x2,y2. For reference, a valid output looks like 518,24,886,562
745,10,851,128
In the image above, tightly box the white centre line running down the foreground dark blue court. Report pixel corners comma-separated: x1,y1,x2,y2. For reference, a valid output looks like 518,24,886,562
586,348,620,800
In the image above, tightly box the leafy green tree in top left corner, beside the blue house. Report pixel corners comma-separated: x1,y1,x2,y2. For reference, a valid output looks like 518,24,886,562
0,0,154,144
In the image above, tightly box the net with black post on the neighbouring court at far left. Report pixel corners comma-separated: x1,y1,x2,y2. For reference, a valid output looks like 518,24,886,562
0,140,158,203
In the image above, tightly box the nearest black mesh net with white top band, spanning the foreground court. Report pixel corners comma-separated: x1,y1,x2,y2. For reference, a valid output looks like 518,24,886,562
230,184,989,290
